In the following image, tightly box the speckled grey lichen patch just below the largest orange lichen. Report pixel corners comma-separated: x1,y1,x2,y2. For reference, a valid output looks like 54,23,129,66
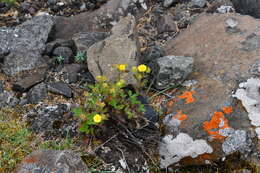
222,130,251,154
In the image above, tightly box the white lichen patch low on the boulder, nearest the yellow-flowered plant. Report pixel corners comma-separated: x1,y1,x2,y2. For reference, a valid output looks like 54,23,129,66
159,133,213,168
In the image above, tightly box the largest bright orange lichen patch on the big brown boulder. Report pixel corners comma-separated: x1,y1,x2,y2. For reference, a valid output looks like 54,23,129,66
203,112,229,139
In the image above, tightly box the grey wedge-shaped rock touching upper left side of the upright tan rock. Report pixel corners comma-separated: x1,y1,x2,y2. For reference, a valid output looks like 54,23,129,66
72,32,108,52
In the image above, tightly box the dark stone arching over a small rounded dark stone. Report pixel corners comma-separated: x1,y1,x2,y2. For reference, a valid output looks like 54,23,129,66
44,39,77,56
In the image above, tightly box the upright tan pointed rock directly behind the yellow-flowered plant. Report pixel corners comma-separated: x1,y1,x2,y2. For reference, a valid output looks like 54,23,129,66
87,15,137,83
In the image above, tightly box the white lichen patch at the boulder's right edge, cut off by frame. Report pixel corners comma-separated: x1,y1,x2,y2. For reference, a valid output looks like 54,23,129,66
233,78,260,139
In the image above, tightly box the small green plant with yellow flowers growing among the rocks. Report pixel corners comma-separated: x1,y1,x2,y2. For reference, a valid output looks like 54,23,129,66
73,64,150,134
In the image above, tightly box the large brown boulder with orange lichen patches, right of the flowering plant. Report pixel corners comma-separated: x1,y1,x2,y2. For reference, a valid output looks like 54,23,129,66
165,14,260,165
